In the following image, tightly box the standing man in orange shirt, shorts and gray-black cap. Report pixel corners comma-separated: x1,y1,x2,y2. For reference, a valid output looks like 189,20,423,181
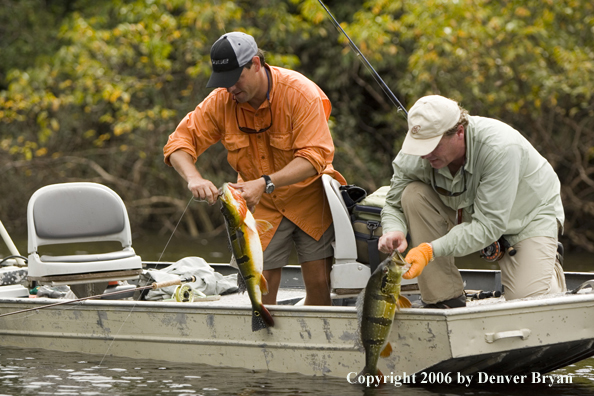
164,32,346,305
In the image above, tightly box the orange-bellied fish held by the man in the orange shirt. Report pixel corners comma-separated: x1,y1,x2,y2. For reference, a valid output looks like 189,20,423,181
219,183,274,331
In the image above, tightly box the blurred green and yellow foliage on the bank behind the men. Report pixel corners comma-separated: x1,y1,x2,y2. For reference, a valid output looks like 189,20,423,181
0,0,594,252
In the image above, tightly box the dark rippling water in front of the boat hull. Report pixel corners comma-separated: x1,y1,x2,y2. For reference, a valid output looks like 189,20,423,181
0,348,594,396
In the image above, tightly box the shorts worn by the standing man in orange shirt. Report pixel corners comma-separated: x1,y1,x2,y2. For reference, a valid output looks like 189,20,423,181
264,217,334,270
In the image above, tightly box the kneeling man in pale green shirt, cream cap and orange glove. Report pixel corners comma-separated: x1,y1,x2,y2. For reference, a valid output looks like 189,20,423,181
379,95,565,308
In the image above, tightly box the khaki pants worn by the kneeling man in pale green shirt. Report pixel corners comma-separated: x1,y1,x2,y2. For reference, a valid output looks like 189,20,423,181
402,182,566,304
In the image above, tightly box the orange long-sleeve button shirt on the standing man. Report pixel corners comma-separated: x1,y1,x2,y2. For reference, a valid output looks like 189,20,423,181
163,65,346,249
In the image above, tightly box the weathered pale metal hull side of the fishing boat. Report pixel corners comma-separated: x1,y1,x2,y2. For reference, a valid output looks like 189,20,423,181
0,286,594,379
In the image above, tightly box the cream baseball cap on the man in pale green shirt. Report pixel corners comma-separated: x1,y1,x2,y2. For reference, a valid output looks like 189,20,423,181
402,95,460,156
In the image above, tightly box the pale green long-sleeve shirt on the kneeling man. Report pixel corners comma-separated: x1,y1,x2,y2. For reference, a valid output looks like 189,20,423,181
382,116,565,257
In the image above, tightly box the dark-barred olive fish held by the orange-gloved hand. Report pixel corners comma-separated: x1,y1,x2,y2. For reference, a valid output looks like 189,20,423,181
357,251,410,376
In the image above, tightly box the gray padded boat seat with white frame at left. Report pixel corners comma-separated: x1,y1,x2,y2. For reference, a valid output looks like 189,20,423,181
27,182,142,290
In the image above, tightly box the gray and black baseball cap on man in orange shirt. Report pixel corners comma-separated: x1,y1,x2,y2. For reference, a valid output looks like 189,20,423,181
206,32,258,88
